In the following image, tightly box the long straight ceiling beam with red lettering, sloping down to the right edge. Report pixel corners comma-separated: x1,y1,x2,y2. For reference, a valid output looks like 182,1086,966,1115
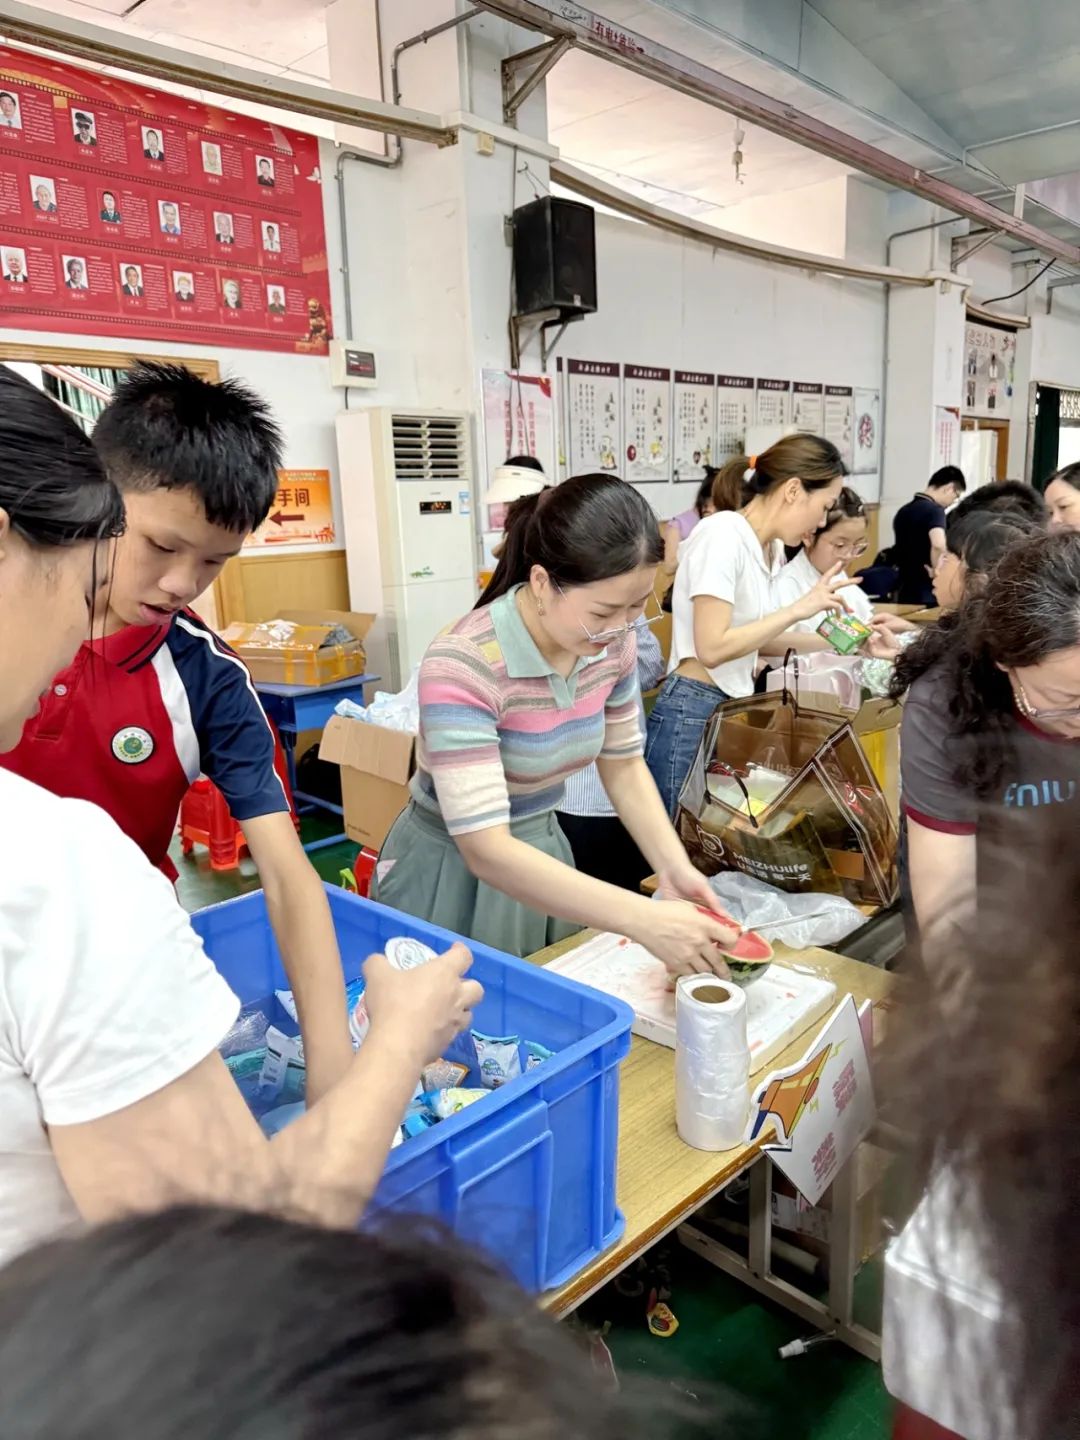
478,0,1080,265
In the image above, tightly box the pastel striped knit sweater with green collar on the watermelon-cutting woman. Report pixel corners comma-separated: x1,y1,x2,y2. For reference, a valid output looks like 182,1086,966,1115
412,581,642,835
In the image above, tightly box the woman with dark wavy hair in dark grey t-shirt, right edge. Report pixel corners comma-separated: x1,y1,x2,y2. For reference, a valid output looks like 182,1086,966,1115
893,531,1080,932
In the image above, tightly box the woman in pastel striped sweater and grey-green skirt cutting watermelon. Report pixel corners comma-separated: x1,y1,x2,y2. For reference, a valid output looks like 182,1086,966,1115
373,475,733,972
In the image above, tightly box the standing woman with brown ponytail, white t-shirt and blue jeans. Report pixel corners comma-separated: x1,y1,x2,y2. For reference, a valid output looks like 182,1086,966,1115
645,435,852,816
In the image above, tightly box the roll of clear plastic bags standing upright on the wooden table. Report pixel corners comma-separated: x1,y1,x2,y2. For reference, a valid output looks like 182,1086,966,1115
675,975,750,1151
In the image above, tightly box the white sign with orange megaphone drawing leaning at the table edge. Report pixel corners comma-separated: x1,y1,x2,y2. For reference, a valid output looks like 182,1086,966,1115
746,995,877,1205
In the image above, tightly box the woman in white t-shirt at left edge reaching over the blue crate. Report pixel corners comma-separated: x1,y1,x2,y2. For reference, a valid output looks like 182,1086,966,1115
0,364,481,1264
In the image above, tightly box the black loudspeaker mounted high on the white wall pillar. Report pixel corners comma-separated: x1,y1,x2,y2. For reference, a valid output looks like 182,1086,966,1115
514,194,596,320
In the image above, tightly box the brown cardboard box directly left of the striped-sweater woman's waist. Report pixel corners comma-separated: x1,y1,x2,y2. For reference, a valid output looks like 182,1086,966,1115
318,716,416,850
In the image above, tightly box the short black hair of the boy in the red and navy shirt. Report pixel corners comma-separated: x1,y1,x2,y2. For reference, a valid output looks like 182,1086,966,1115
94,360,282,534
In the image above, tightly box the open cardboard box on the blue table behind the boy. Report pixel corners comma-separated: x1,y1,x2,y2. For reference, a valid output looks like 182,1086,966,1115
222,611,376,685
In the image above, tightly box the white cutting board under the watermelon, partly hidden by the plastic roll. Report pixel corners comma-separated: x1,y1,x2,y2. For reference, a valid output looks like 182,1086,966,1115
546,935,837,1074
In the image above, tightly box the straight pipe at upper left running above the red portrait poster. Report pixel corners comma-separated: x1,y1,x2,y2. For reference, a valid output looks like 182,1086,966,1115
0,0,458,145
